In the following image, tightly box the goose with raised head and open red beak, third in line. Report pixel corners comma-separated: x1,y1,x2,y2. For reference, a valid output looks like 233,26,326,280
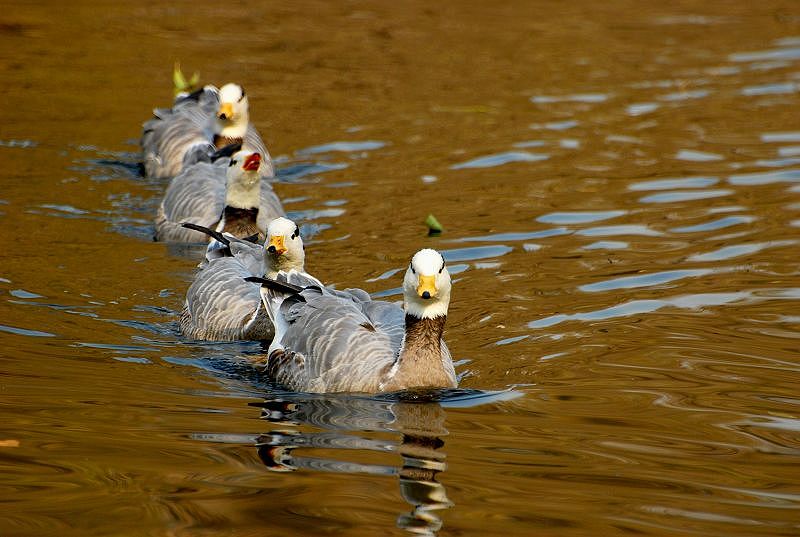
153,151,285,242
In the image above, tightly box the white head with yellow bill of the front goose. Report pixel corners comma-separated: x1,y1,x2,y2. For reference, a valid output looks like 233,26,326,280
403,248,450,319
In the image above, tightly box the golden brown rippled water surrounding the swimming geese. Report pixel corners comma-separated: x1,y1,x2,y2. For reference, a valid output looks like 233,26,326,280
0,0,800,536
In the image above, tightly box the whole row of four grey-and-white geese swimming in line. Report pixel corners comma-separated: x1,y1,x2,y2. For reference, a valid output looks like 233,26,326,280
141,84,457,393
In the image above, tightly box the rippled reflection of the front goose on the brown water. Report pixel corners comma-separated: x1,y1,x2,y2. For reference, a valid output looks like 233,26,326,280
251,390,519,535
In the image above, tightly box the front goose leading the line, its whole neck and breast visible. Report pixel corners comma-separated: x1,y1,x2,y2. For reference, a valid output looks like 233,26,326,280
250,249,457,393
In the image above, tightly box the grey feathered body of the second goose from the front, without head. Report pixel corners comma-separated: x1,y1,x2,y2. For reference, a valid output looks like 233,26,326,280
180,257,273,341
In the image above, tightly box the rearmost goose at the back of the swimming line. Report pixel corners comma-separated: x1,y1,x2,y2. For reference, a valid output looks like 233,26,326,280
140,84,274,177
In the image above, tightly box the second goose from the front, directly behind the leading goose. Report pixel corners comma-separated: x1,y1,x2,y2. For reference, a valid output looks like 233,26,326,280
180,217,312,341
